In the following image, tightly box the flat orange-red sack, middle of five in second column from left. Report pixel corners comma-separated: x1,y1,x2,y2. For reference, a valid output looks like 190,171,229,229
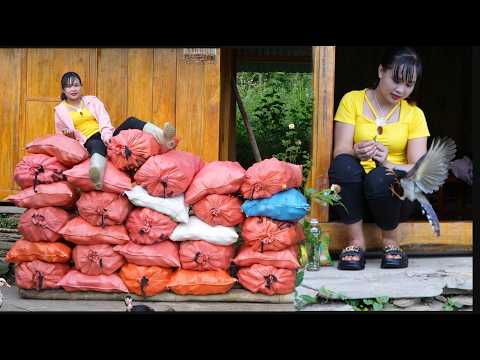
59,216,130,245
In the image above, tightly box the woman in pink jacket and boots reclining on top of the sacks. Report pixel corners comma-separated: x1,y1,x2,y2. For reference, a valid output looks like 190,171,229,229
55,72,176,190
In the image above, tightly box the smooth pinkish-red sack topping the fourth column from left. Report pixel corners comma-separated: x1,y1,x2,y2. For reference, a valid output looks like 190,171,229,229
185,161,245,205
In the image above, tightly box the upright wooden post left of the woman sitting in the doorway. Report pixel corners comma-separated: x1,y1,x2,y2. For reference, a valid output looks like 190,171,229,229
309,46,335,222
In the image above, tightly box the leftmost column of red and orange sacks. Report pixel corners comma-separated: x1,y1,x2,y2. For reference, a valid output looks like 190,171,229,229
6,135,88,290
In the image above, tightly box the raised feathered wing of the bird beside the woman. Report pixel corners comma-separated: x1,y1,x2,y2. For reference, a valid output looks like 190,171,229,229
405,138,457,194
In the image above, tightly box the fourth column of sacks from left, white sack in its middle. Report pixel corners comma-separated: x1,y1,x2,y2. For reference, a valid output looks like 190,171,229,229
164,161,245,295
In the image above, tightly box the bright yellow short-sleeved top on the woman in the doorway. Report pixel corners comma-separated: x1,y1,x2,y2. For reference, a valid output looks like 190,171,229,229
334,89,430,173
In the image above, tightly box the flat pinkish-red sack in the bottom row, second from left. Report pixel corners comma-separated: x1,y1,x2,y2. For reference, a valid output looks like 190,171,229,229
57,269,128,293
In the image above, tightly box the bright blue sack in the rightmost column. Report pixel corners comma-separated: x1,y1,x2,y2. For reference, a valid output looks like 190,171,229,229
242,189,310,221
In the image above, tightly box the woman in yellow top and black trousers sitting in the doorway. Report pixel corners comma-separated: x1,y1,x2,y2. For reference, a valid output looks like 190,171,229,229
329,48,430,270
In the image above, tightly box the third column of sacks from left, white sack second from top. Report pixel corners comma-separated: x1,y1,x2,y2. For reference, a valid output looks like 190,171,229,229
119,150,204,296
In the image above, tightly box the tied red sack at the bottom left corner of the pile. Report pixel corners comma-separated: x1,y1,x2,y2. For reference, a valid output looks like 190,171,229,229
15,260,70,291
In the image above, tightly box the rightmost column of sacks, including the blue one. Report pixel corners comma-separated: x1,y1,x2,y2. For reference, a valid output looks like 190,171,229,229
234,158,309,295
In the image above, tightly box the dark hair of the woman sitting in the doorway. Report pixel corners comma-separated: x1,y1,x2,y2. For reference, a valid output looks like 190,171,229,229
371,47,422,105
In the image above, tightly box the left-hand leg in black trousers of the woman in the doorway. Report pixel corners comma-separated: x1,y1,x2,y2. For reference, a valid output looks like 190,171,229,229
328,154,365,261
